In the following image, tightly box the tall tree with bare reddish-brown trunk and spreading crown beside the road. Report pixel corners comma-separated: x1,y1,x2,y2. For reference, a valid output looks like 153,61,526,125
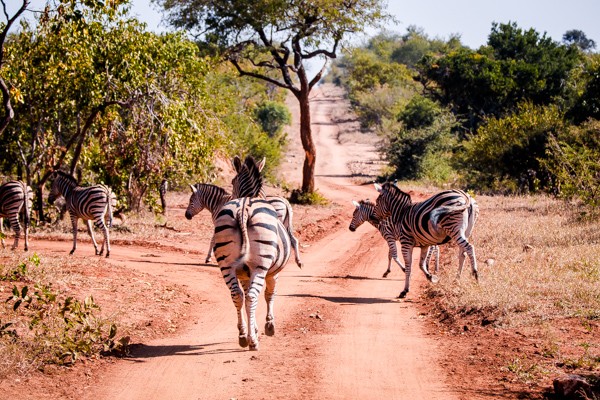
156,0,386,193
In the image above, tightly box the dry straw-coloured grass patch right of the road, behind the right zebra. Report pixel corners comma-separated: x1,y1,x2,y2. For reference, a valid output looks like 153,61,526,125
429,196,600,327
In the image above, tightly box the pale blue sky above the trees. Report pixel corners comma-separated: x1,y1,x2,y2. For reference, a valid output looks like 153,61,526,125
123,0,600,51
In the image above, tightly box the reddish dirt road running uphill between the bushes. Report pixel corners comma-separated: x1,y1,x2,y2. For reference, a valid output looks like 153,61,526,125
19,86,461,400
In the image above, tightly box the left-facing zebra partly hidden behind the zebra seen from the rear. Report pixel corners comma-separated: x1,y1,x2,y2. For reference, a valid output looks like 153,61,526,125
185,183,302,268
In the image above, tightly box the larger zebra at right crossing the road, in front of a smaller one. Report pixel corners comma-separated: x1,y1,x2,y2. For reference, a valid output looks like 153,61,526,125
375,182,479,298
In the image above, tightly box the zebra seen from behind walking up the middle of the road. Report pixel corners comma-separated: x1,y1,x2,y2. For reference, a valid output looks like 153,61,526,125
214,156,291,350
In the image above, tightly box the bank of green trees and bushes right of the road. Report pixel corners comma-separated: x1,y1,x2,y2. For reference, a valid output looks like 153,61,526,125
329,23,600,205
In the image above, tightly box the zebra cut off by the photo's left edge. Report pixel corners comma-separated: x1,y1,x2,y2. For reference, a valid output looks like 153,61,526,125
0,181,33,251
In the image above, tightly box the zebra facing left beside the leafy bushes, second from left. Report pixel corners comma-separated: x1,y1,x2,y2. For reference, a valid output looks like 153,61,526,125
48,171,116,257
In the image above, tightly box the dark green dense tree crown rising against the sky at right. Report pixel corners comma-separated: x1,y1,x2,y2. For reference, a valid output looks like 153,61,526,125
419,23,580,131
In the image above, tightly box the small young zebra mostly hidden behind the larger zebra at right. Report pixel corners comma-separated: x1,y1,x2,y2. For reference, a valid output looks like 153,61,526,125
349,200,440,278
